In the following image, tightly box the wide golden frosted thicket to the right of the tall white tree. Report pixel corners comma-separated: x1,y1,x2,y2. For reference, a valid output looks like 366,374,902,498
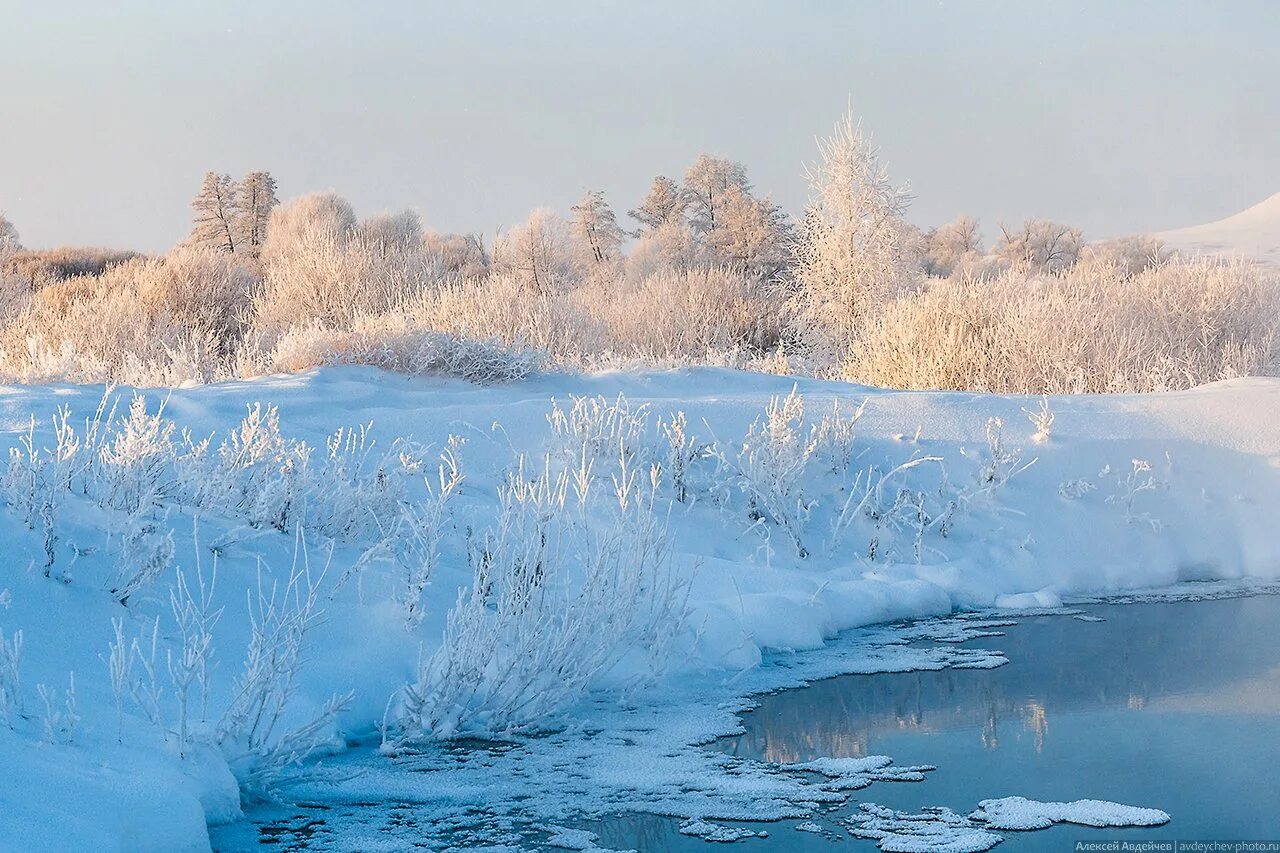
840,257,1280,394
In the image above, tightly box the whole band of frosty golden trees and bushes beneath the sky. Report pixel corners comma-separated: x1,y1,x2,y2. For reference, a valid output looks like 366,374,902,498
0,109,1277,393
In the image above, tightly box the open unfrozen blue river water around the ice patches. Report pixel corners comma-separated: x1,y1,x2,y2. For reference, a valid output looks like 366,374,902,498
591,596,1280,852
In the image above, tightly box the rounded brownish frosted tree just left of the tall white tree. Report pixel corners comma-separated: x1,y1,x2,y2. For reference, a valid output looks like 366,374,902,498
705,186,792,282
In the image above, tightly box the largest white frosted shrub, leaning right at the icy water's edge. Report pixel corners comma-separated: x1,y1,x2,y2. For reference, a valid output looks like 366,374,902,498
384,450,684,737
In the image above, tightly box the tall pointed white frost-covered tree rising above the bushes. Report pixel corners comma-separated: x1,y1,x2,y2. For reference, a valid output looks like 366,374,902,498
795,114,913,347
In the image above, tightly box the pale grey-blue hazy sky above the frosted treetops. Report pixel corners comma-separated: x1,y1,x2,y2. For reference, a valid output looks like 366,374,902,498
0,0,1280,251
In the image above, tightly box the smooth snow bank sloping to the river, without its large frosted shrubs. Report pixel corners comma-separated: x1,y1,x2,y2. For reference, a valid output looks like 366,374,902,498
0,368,1280,849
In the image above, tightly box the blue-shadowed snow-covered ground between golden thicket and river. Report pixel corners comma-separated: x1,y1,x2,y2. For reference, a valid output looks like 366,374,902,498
0,368,1280,850
